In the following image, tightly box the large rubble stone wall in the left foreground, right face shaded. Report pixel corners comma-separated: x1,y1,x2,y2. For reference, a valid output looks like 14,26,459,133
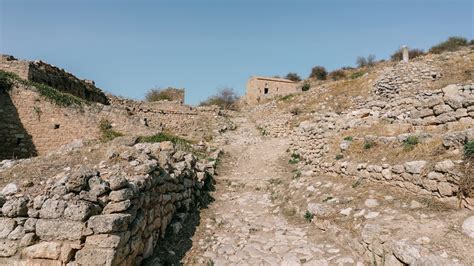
0,142,220,265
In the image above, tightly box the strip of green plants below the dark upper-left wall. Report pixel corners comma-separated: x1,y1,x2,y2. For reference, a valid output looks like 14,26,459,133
0,71,87,107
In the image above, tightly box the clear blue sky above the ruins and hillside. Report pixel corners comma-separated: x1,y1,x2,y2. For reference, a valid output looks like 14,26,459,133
0,0,474,104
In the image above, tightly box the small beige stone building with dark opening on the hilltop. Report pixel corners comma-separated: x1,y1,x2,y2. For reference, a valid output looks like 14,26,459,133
245,76,300,104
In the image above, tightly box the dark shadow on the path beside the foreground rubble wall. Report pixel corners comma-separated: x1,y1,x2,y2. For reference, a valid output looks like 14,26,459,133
142,177,215,266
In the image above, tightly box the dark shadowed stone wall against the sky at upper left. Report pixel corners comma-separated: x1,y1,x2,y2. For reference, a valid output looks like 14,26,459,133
0,55,108,104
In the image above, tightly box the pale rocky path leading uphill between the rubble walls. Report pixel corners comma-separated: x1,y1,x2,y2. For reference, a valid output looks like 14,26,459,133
183,118,358,265
